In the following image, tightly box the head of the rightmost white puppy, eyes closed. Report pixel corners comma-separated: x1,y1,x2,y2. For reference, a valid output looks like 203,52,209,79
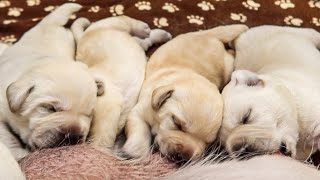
219,70,298,156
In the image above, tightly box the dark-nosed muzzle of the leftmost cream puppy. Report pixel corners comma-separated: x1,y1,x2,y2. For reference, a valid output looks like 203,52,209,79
27,112,91,150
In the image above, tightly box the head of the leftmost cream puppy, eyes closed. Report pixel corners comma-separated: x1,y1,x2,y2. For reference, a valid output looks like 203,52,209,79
6,62,97,149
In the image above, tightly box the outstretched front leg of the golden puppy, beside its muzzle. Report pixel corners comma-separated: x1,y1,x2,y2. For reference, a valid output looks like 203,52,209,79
123,106,151,158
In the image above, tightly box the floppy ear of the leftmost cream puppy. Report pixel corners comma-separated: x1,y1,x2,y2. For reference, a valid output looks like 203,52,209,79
6,78,35,113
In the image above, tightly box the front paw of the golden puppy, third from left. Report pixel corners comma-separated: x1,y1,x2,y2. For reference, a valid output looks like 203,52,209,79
122,139,150,158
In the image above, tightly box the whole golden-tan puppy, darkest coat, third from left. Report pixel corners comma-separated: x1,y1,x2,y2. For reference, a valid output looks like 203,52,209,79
123,25,247,161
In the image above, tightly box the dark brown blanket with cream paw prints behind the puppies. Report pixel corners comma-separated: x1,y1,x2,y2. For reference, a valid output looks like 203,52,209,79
0,0,320,43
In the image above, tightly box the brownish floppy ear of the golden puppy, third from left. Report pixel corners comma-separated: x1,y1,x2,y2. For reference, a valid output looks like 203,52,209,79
151,85,174,110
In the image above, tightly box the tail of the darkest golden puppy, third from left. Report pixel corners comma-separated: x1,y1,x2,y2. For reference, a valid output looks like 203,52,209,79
208,24,249,43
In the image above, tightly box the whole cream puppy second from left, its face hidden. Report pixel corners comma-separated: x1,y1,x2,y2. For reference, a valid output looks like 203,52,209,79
71,16,171,148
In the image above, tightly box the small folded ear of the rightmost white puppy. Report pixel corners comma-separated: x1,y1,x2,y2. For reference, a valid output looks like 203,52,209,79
231,70,264,87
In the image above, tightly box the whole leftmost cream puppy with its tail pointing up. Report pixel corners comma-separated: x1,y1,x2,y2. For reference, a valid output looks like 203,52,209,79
0,3,97,160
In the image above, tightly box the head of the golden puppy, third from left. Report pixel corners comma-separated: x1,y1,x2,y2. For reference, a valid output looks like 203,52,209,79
151,79,223,161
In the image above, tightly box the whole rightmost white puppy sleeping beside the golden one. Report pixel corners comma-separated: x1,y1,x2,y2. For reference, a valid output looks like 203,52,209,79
220,26,320,159
